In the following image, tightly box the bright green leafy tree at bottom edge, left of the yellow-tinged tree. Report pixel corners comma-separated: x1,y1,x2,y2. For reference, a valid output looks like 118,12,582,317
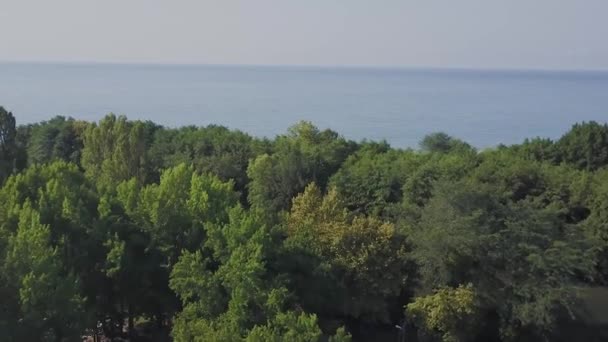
170,202,292,341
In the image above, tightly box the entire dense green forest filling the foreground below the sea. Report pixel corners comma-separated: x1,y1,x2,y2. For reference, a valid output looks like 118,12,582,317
0,107,608,342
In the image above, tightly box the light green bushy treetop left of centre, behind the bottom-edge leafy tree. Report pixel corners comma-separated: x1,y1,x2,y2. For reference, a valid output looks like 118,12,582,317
125,164,238,265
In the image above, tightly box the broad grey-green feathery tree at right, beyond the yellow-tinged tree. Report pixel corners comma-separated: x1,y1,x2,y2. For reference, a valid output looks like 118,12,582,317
412,182,594,340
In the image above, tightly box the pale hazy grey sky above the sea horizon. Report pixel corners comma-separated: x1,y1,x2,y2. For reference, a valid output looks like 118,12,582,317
0,0,608,69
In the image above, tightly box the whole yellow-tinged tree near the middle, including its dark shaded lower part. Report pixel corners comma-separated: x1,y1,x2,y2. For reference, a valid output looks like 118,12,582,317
286,183,410,322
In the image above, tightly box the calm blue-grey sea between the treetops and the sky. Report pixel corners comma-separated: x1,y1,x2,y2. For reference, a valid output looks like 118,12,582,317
0,63,608,148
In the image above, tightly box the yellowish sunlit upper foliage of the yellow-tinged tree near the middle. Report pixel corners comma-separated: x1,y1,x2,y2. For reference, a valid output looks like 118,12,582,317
287,183,406,295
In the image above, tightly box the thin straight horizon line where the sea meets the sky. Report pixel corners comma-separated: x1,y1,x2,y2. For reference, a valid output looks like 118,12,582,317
0,60,608,73
